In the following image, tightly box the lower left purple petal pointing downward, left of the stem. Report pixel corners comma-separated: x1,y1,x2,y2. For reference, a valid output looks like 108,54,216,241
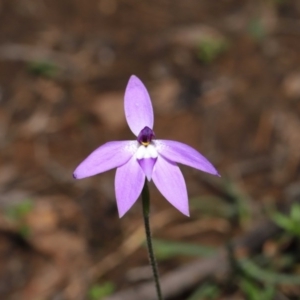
115,157,145,218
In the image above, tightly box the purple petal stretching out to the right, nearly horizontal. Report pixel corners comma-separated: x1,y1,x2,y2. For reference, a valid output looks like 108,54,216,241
155,140,220,176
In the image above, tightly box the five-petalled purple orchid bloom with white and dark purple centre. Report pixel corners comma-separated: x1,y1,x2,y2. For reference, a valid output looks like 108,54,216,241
74,75,219,218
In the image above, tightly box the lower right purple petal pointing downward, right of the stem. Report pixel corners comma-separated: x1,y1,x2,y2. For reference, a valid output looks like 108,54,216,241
152,155,189,216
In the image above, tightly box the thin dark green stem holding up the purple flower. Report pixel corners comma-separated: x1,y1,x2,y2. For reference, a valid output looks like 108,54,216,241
142,179,163,300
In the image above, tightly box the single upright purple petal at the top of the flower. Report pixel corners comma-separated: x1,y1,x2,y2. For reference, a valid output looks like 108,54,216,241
124,75,153,136
